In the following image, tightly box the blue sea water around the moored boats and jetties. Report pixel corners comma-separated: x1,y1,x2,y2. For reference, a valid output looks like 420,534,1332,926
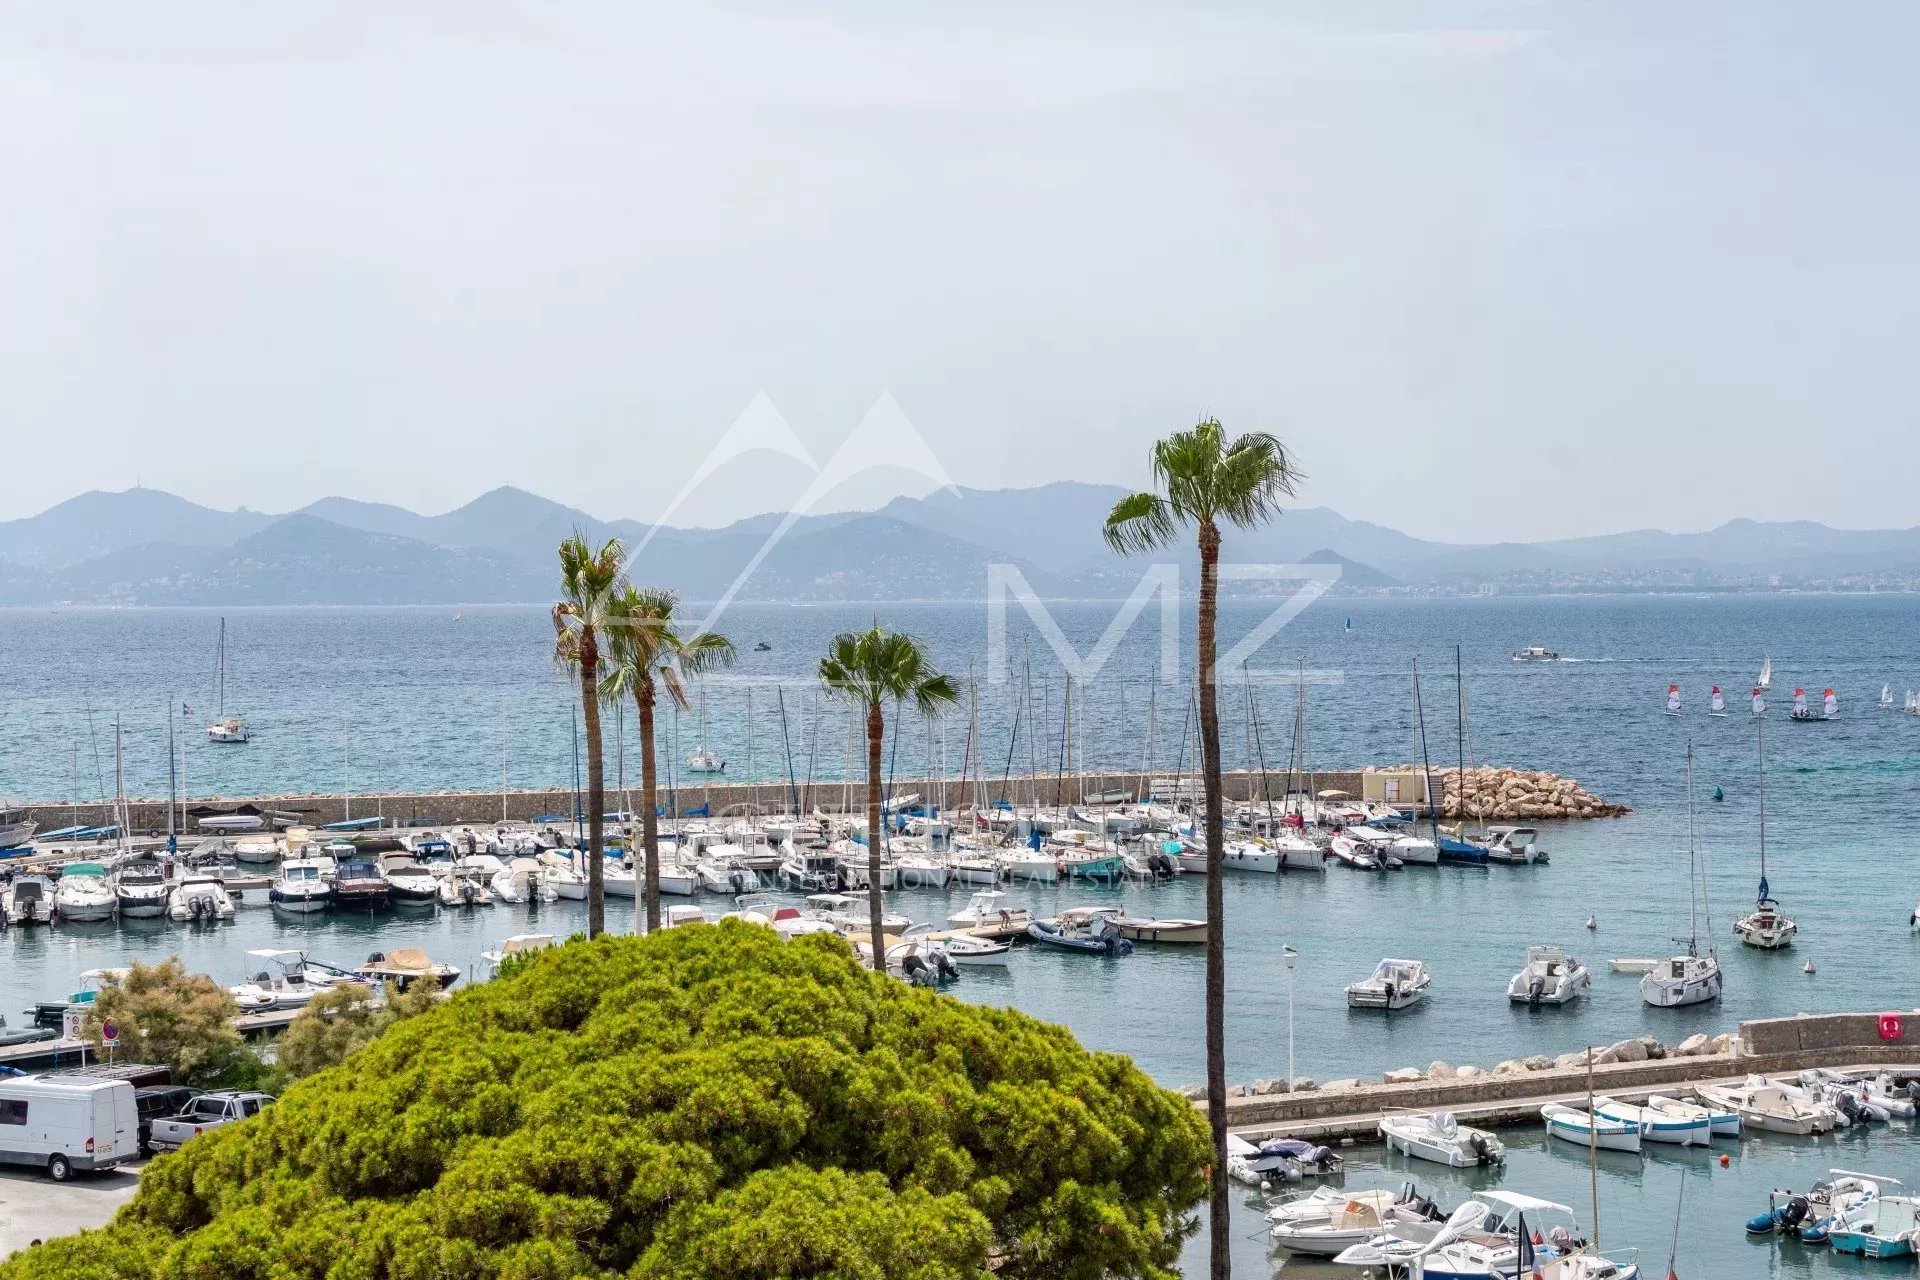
0,595,1920,1276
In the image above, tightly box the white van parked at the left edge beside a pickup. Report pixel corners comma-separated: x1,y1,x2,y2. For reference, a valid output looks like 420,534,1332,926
0,1075,140,1182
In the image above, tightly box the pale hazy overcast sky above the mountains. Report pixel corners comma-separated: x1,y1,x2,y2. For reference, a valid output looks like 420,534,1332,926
0,0,1920,539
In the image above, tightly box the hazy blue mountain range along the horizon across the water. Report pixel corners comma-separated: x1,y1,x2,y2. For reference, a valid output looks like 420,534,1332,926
0,482,1920,604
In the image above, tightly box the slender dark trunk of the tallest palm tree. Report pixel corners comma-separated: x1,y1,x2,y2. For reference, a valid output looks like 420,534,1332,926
1198,520,1233,1280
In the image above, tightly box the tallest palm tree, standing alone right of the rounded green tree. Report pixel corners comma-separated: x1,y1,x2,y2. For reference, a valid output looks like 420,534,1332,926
1106,418,1300,1280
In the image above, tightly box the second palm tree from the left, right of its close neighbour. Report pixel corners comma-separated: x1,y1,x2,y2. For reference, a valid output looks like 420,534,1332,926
601,585,733,933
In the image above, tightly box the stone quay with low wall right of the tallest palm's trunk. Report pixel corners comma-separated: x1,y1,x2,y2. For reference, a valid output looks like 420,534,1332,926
1221,1009,1920,1142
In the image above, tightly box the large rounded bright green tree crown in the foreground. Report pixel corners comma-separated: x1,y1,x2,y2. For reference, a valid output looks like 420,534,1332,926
0,921,1208,1280
